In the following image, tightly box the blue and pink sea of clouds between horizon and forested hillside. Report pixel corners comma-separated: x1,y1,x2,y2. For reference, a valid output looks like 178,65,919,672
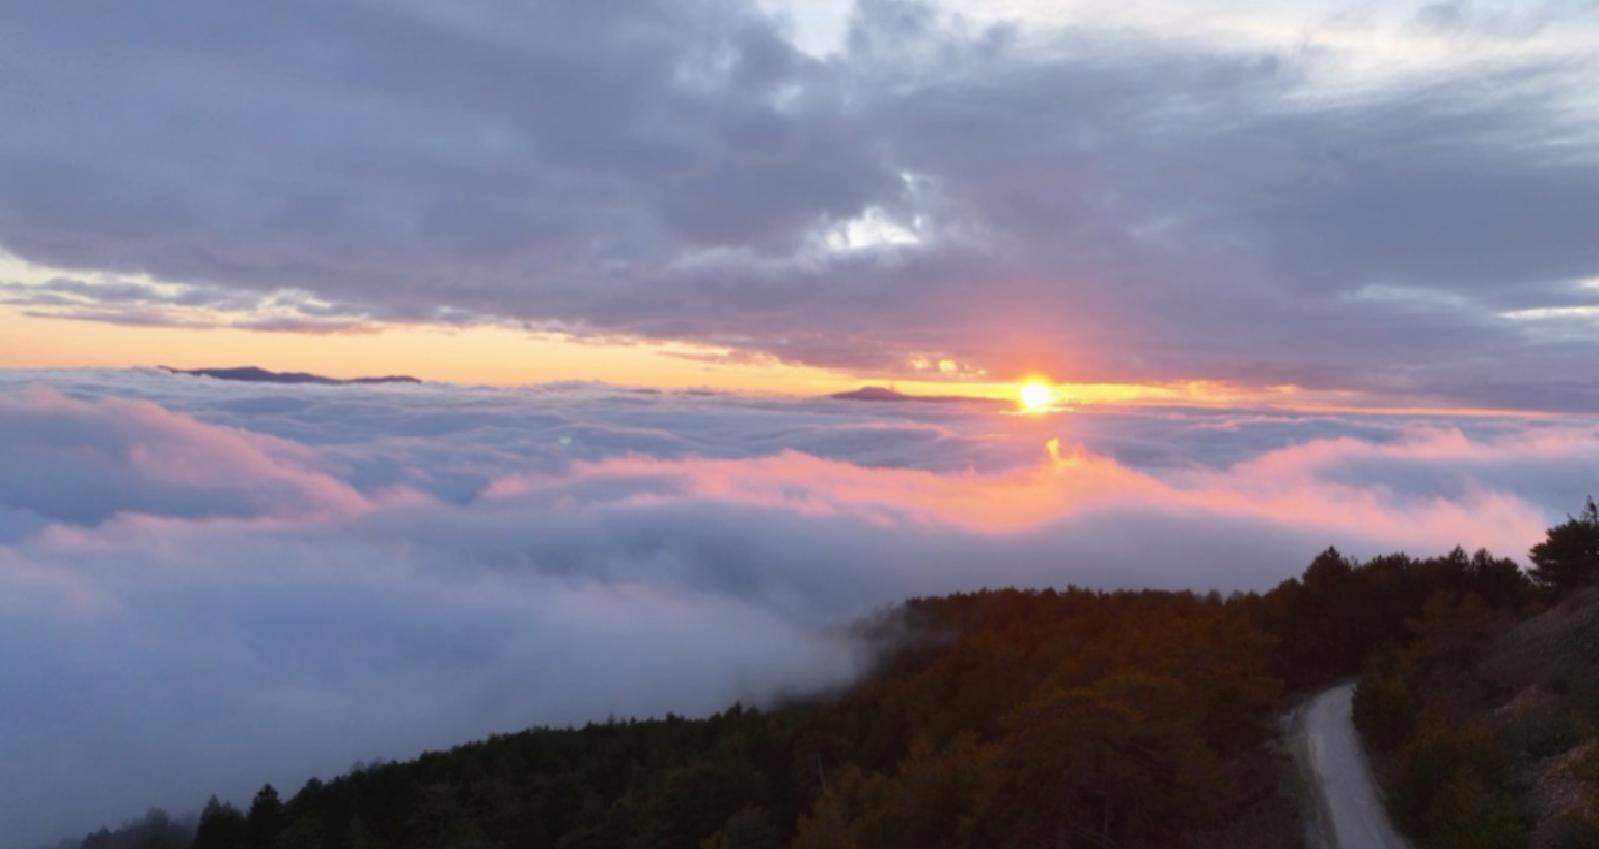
0,371,1599,846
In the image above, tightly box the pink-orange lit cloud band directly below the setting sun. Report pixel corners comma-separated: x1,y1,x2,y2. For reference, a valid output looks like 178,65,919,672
486,428,1560,562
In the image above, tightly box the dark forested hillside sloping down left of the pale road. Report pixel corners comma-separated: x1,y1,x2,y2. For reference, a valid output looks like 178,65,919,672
59,511,1573,849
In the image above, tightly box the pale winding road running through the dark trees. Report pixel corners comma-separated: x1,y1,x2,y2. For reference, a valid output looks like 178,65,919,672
1287,683,1410,849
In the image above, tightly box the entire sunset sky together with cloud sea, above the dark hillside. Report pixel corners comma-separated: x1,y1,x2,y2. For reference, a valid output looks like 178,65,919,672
0,0,1599,849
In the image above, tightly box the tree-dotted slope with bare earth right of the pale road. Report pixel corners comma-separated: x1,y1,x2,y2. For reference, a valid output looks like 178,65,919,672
1354,500,1599,849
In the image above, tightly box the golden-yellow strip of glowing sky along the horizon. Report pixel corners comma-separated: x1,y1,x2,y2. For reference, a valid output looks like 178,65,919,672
0,307,1538,416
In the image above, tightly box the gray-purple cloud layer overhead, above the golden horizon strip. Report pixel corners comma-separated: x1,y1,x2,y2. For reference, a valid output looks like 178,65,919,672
0,0,1599,411
